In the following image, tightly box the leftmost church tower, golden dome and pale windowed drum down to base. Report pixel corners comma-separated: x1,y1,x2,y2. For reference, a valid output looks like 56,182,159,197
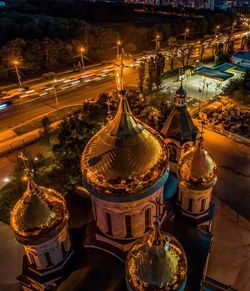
10,156,72,290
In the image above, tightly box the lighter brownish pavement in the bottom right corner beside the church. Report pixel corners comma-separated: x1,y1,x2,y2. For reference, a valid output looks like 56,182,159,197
208,199,250,291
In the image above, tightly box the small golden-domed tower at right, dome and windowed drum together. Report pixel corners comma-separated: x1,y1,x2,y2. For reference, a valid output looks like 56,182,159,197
178,135,217,222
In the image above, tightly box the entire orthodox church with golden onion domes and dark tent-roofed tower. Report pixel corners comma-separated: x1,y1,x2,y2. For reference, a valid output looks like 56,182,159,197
11,59,223,291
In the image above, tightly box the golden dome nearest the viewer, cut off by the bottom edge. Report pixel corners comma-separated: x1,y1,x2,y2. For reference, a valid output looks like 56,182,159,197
126,222,187,291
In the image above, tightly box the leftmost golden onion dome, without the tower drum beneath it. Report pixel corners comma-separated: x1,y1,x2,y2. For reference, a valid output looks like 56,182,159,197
10,178,69,238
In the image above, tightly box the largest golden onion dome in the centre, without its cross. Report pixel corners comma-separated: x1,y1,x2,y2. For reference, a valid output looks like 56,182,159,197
81,96,168,196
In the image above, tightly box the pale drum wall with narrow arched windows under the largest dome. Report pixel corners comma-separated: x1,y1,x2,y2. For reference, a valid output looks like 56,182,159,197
91,186,163,239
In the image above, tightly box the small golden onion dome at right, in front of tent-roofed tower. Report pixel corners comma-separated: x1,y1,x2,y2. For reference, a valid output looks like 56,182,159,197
179,137,217,189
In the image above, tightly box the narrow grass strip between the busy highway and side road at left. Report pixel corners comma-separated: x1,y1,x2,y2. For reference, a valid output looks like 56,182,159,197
13,106,81,135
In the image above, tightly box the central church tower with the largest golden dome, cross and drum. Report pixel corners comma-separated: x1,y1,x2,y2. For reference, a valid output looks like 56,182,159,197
81,54,169,260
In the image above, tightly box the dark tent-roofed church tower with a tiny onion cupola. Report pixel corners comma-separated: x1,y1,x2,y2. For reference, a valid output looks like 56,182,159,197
161,83,198,175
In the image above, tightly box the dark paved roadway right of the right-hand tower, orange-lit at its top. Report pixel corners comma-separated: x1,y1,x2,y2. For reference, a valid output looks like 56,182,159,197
204,126,250,220
